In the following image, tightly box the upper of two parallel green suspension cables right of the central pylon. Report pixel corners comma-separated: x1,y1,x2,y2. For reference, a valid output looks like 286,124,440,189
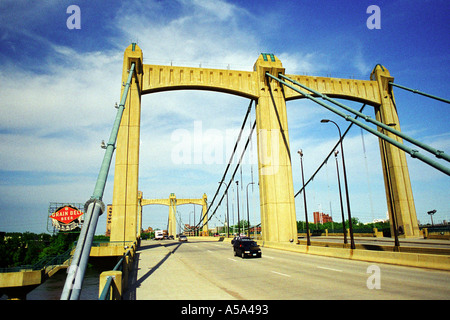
278,74,450,161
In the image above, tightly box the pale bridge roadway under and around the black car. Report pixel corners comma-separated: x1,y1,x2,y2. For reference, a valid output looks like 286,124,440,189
124,240,450,300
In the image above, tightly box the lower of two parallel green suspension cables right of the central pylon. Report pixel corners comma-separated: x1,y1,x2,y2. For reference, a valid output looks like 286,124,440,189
266,72,450,176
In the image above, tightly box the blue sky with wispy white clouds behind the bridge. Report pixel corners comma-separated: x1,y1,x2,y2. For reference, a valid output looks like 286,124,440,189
0,0,450,234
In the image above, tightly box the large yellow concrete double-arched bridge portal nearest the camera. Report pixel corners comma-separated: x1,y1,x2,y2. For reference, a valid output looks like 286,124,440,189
111,44,418,242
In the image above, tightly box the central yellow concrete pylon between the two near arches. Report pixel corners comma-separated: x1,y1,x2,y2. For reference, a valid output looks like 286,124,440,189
254,55,297,242
